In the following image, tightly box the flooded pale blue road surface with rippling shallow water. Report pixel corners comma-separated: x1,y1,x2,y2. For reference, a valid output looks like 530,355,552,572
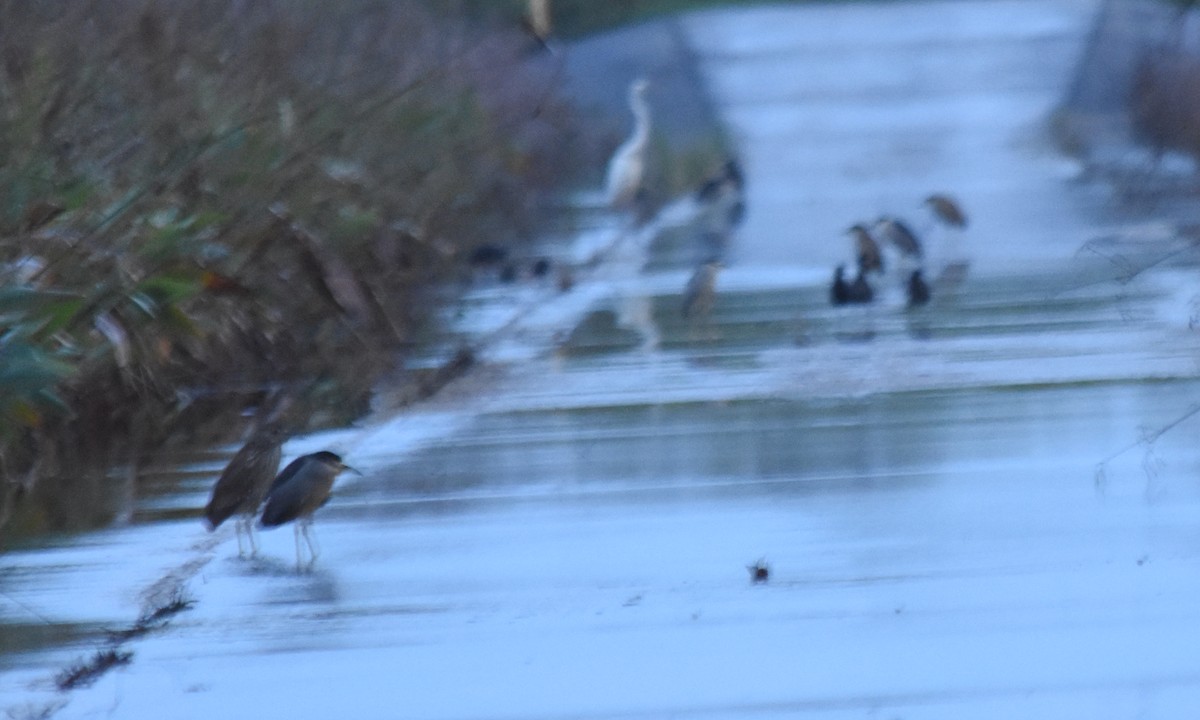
11,0,1200,719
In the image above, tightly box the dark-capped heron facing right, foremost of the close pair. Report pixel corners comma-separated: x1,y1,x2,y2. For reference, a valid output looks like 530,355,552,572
259,450,358,569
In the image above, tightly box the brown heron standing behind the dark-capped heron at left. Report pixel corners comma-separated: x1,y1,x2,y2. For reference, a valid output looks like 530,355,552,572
204,425,287,557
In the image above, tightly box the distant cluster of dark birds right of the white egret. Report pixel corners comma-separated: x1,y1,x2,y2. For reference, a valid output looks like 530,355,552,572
829,193,967,307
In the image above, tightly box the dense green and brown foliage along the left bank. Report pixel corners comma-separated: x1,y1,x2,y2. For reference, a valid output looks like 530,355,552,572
0,0,595,540
